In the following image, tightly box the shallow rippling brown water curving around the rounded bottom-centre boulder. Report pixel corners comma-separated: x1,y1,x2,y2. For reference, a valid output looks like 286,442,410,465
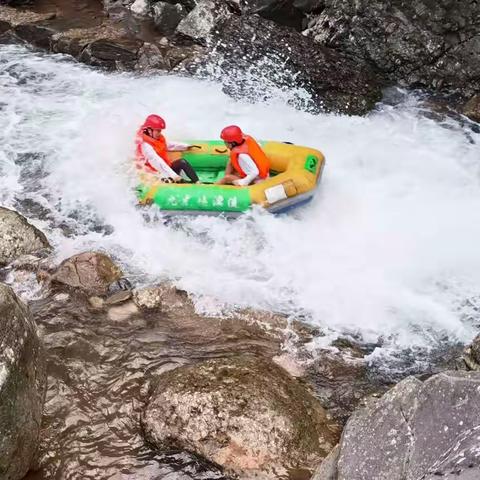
27,293,280,480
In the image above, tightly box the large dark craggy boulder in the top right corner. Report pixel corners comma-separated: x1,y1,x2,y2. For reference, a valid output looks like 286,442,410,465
305,0,480,97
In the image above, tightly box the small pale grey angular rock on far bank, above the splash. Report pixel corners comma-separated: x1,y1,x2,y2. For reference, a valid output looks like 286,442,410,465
176,0,235,43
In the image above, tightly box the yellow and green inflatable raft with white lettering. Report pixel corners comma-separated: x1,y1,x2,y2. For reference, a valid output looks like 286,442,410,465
137,140,325,217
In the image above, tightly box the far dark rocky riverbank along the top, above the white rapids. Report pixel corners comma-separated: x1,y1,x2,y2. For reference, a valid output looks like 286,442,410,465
0,0,480,121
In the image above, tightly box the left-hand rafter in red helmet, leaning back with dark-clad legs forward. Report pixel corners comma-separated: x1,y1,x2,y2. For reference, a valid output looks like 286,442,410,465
135,115,199,183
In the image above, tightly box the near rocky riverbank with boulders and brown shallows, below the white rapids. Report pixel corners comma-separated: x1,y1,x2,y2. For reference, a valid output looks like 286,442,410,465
0,204,480,480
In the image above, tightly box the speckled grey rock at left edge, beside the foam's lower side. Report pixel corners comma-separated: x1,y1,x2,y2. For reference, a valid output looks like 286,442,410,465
0,207,51,265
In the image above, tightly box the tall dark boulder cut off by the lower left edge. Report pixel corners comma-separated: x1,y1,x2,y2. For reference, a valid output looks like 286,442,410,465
0,284,46,480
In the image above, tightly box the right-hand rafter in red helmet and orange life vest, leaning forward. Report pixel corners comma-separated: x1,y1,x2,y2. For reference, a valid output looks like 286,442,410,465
217,125,270,187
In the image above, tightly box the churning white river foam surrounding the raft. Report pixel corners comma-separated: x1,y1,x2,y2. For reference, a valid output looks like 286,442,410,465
0,47,480,358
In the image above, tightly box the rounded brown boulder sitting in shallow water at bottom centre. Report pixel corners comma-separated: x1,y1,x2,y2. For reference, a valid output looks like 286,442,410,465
143,356,337,479
